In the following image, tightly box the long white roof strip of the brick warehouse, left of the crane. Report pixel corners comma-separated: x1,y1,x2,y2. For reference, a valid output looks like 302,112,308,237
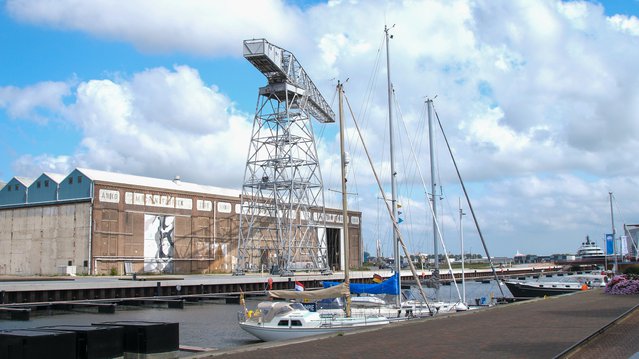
76,168,241,197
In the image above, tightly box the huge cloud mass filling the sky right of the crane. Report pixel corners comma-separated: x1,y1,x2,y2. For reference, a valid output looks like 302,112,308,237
302,1,639,255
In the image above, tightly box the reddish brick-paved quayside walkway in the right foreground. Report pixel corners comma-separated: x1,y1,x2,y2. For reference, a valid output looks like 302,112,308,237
192,289,639,358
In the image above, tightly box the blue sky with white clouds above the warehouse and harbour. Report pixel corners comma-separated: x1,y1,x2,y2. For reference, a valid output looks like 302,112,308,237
0,0,639,257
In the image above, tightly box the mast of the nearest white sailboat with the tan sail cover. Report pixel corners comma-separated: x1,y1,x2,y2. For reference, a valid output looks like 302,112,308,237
337,81,351,317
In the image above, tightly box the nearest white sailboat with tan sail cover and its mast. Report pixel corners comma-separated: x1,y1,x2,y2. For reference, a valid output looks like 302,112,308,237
239,83,390,341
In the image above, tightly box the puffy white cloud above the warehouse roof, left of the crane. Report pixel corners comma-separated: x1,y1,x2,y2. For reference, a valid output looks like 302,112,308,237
0,66,250,188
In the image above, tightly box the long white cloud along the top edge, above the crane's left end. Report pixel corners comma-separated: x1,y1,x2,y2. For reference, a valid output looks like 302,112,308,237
7,0,302,56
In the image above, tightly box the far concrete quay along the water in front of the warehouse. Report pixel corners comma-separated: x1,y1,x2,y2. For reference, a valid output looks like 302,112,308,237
0,266,556,306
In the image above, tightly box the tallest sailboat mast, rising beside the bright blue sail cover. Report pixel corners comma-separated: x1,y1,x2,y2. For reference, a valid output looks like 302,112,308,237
384,25,402,306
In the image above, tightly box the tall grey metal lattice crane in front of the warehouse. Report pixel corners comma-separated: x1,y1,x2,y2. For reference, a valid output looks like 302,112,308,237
234,39,335,275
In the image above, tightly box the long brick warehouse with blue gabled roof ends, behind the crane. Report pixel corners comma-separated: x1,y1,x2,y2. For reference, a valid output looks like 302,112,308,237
0,168,362,275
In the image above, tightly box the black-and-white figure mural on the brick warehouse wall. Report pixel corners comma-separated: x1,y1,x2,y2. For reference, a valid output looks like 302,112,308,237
144,214,175,273
